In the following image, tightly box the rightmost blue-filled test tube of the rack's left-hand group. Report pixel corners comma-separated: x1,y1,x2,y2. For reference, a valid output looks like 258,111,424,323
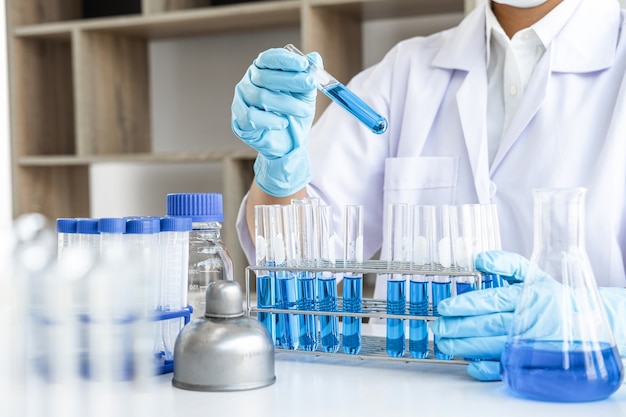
341,205,363,355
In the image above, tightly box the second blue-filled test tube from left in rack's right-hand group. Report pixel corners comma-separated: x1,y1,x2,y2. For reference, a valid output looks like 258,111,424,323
409,205,437,359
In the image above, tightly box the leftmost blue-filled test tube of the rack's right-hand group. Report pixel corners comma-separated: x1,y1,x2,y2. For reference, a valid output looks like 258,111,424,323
386,203,410,358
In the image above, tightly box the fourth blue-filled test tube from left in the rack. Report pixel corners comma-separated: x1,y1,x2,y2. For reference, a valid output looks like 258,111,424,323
316,205,339,353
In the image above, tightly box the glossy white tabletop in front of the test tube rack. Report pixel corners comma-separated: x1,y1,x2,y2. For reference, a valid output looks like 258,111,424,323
150,352,626,417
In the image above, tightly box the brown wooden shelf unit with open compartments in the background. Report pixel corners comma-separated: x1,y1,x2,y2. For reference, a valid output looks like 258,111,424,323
6,0,473,283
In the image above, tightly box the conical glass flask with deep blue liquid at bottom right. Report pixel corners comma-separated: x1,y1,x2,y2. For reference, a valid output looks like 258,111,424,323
501,188,624,402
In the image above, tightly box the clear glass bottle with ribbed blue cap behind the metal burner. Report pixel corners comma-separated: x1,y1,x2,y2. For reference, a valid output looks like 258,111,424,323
167,193,233,318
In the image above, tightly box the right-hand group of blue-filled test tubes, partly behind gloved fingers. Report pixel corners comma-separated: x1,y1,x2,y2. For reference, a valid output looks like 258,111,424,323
383,203,503,360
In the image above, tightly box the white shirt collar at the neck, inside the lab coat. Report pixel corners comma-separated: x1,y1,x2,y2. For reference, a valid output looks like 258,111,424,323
485,0,582,65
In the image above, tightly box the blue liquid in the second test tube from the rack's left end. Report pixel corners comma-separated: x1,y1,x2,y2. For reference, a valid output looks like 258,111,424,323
276,273,300,350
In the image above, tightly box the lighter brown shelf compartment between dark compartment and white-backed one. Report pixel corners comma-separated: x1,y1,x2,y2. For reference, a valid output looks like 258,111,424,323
73,31,151,155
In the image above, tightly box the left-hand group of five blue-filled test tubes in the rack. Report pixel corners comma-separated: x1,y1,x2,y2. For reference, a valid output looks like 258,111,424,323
255,198,363,354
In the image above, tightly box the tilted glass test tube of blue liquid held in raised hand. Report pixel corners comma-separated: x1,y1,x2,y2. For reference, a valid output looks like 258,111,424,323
285,44,387,134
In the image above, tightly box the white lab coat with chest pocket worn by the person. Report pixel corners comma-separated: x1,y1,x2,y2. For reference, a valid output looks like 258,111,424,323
238,0,626,292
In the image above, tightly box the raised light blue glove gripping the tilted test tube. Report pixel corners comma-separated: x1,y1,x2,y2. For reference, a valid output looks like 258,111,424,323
231,48,323,197
